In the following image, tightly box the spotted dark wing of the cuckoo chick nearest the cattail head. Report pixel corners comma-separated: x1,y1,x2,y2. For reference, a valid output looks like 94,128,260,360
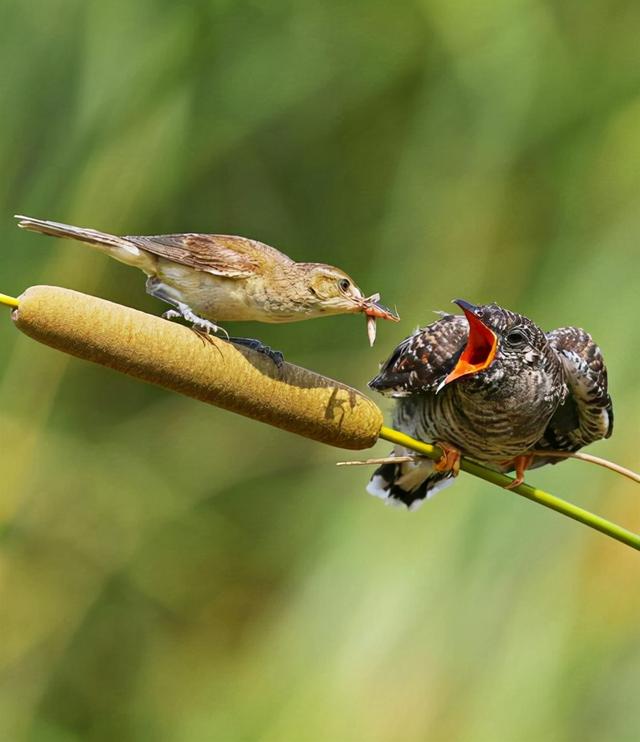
369,314,469,397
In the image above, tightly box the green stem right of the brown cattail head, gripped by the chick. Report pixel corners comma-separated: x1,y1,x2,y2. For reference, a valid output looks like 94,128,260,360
380,426,640,551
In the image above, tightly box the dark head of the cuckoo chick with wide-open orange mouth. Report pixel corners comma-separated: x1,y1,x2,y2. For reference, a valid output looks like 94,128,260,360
439,299,553,388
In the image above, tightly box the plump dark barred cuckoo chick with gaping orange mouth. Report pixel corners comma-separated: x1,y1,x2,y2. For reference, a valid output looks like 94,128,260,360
367,299,613,507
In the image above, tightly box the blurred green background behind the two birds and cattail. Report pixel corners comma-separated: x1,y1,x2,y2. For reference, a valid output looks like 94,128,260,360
0,0,640,742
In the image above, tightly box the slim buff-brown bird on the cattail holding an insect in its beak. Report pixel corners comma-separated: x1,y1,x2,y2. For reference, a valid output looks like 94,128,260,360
16,216,399,363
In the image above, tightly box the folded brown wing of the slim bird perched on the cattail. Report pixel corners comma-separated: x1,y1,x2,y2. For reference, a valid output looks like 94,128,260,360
125,234,264,278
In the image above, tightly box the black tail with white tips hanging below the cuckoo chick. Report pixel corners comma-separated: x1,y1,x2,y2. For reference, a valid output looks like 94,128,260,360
367,449,454,510
